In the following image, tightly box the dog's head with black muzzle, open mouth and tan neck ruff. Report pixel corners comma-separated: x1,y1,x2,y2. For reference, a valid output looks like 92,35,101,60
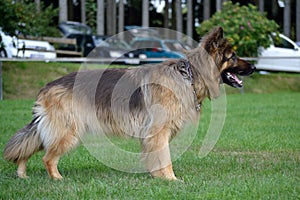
187,27,255,97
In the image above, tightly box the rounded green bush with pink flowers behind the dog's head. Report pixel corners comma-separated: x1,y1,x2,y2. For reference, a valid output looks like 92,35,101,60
197,1,279,57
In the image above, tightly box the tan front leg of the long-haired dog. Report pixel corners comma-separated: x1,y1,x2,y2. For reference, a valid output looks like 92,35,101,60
142,128,177,180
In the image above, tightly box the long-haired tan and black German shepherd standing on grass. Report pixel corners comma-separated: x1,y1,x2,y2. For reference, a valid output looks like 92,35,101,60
4,27,255,180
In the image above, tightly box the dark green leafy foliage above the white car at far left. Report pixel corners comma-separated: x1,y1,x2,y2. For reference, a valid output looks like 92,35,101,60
0,0,59,36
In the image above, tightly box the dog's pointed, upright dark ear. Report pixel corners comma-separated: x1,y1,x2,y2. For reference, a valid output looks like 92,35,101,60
202,26,224,54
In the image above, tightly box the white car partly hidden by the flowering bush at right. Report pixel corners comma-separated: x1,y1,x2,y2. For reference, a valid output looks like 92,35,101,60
255,34,300,72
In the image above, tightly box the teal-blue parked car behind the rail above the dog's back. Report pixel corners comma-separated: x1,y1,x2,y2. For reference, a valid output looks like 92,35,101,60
130,37,184,58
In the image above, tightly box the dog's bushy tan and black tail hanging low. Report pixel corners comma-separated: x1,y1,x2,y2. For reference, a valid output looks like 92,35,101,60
3,121,43,163
